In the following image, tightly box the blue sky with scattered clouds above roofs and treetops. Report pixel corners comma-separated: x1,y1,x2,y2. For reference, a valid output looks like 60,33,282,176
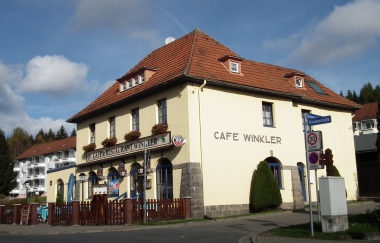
0,0,380,136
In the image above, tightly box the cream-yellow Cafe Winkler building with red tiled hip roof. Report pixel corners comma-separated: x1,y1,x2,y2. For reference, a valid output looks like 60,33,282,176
68,29,360,217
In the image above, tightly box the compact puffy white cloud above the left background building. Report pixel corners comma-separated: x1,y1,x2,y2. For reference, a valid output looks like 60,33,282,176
17,56,88,96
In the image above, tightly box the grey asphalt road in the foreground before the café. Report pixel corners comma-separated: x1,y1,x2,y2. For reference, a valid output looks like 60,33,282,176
0,202,380,243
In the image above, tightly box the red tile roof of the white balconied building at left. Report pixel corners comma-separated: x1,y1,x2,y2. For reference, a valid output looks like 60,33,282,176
15,136,77,160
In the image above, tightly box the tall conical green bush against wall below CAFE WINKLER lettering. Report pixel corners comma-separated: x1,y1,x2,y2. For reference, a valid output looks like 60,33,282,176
250,161,282,212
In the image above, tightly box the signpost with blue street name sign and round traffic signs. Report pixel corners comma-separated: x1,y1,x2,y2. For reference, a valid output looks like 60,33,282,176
303,113,331,236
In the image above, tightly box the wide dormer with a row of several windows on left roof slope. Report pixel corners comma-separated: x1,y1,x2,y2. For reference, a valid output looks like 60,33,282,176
116,67,157,92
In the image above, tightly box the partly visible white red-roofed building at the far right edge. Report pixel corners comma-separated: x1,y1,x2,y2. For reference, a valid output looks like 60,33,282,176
352,102,378,136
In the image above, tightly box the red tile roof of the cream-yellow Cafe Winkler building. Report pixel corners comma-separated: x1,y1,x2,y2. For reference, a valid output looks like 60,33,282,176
68,29,360,122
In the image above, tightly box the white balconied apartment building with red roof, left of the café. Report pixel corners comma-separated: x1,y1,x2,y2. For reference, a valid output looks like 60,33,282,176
10,137,76,198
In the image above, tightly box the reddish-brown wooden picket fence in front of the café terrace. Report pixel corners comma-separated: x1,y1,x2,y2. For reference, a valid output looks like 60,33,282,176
0,198,190,226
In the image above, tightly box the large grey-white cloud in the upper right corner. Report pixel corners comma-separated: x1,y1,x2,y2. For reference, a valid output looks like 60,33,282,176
264,0,380,65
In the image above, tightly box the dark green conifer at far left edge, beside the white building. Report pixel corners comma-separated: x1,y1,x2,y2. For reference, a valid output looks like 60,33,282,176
0,129,17,196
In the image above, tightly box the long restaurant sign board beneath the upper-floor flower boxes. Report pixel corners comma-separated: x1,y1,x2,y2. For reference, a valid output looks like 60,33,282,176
87,132,171,162
